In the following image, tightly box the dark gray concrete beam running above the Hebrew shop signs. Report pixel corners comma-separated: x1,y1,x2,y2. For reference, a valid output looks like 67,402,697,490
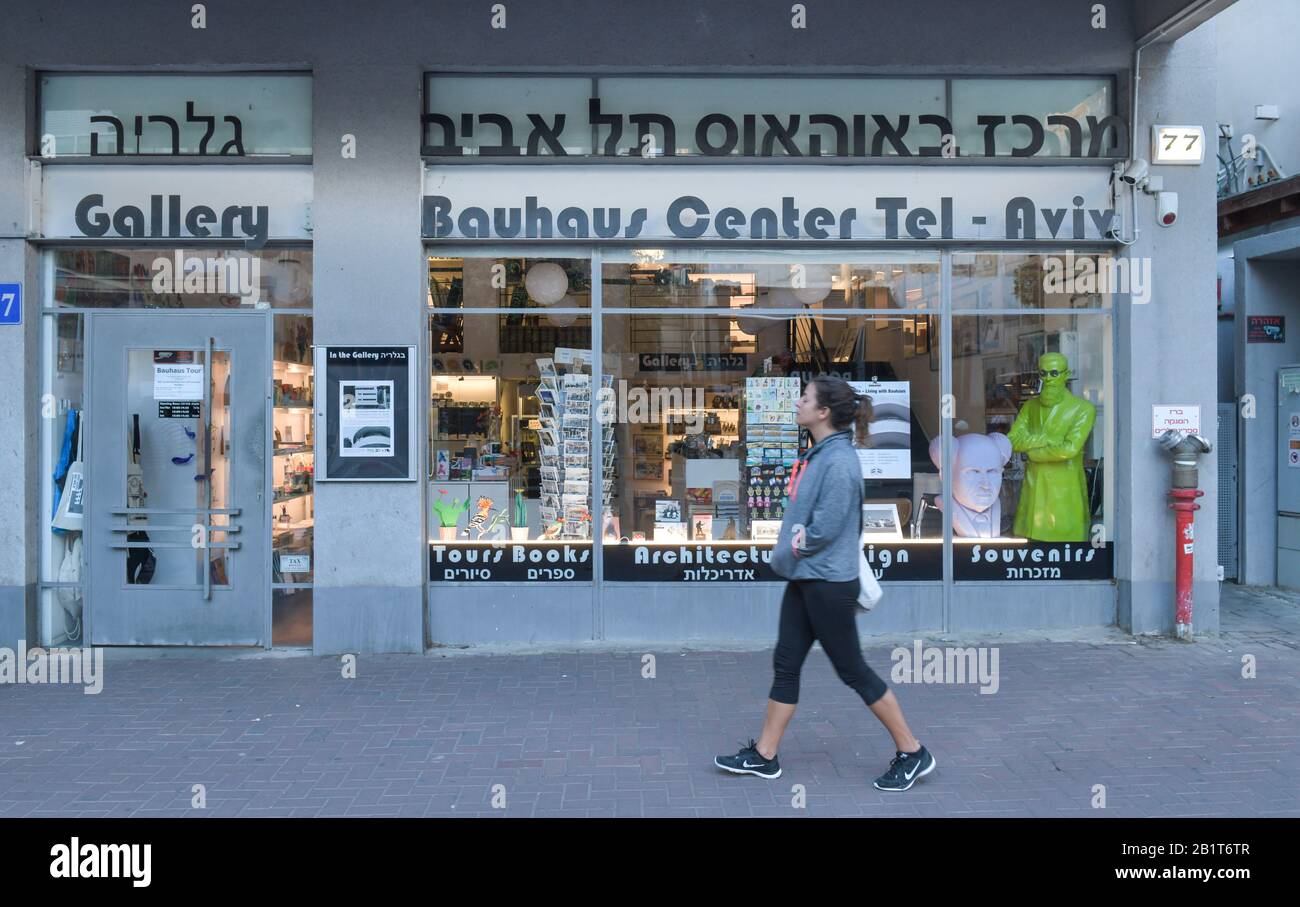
0,0,1133,72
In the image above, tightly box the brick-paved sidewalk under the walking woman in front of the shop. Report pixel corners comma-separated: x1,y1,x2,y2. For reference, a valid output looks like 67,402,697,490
0,586,1300,816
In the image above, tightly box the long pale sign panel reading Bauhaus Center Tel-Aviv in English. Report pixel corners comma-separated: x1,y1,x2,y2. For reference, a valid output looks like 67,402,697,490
423,164,1115,242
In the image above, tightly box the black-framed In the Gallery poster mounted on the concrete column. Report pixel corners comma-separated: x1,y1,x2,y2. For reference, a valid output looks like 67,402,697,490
316,347,416,482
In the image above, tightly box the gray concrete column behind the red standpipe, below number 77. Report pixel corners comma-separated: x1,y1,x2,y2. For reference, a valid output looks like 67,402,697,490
1115,22,1218,633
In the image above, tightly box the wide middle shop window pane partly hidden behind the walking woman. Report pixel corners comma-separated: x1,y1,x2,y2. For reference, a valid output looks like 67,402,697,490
602,255,943,582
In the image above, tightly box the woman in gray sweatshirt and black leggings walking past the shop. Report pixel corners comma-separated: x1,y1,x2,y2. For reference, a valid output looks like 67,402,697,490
714,376,935,790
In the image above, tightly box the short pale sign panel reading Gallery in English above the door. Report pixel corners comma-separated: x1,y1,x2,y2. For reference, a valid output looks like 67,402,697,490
40,164,312,248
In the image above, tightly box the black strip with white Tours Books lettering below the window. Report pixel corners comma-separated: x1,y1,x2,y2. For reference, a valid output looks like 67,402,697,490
429,542,592,582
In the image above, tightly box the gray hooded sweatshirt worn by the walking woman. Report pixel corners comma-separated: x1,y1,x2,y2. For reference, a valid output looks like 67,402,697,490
771,430,862,582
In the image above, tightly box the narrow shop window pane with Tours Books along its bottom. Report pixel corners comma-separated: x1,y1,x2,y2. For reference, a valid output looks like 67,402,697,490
428,257,597,581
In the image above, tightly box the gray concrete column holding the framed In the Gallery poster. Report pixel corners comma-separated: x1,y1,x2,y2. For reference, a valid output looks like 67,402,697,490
312,62,428,654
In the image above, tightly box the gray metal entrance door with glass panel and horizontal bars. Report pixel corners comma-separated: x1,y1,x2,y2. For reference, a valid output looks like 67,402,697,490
86,313,270,646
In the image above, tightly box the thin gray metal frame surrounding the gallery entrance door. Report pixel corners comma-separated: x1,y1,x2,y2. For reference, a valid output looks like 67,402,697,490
82,309,274,641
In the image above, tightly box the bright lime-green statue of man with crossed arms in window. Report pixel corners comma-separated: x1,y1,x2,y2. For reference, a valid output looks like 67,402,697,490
1008,352,1097,542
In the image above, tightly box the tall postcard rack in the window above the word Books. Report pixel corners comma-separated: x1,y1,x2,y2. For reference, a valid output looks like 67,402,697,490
537,348,615,539
